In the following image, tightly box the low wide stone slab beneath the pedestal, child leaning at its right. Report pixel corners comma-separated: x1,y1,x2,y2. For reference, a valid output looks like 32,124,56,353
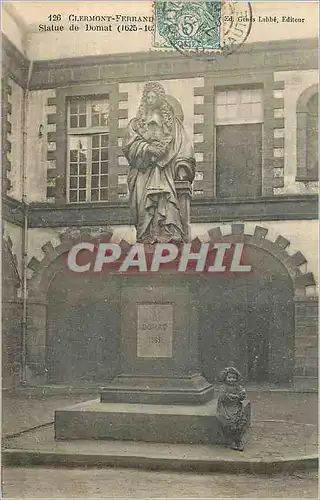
54,400,250,444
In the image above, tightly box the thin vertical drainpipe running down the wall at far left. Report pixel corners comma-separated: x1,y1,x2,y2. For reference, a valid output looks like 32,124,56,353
20,61,33,385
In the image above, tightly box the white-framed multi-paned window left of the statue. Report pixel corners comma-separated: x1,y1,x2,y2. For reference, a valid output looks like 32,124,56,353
68,96,109,203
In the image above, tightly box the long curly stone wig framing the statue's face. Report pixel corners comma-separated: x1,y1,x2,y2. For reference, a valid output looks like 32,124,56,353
136,82,174,131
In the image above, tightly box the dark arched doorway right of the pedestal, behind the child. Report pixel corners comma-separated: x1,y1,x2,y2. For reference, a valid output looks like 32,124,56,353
198,247,294,383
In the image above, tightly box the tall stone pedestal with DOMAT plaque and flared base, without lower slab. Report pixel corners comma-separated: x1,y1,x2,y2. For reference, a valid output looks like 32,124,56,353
101,284,213,404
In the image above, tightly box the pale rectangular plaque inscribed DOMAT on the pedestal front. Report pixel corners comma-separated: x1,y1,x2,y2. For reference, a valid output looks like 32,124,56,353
137,304,173,358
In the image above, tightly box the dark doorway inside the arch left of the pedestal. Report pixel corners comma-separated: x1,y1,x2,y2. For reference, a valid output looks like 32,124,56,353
46,273,120,385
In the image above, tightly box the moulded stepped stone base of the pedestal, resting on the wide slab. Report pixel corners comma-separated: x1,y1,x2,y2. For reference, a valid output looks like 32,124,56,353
101,374,214,405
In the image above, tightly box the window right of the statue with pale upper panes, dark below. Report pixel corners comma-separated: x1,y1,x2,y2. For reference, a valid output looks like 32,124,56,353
215,88,262,198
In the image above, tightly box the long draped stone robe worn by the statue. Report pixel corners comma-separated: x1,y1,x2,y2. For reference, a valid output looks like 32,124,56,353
123,114,195,242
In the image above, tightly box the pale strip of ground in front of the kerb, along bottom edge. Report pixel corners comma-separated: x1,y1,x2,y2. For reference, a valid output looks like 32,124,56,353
2,468,318,500
